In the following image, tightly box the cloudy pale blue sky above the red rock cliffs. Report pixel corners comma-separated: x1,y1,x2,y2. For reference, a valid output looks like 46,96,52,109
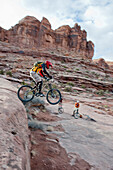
0,0,113,61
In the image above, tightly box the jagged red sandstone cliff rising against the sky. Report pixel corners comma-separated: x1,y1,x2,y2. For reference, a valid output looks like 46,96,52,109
0,16,94,59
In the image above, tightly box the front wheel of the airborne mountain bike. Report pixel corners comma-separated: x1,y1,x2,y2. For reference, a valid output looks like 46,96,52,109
46,89,61,105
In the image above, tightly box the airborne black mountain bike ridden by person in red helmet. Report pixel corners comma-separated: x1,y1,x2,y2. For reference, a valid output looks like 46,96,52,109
17,79,61,105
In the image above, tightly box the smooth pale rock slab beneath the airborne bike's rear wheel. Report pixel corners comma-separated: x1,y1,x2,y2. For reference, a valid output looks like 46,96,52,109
0,78,30,170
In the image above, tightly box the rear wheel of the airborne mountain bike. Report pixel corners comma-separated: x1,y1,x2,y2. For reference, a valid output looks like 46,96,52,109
17,85,34,102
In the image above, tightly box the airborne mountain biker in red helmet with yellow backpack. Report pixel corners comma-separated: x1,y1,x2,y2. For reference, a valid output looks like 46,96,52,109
30,61,53,96
